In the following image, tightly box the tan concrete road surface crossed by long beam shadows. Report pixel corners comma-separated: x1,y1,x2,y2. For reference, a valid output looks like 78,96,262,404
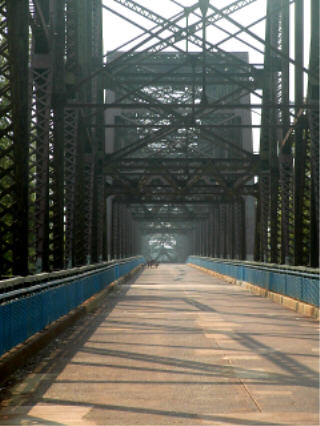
0,265,319,425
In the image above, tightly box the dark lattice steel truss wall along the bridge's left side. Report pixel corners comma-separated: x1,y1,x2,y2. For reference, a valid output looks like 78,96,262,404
0,0,106,275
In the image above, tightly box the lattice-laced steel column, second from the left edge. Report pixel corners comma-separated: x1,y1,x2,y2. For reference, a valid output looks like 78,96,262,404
30,0,53,272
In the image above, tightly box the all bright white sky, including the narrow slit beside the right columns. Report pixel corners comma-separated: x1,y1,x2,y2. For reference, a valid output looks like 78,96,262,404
103,0,311,151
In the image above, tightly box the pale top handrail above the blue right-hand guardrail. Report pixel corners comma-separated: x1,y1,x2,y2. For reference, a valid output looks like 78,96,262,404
189,255,320,279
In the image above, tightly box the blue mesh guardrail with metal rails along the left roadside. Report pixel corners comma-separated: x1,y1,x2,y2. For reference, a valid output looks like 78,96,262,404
0,256,144,356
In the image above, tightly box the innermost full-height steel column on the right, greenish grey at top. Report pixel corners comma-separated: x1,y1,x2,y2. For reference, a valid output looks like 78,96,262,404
258,0,281,262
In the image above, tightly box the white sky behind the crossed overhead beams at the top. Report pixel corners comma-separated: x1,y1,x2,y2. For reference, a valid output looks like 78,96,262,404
103,0,310,66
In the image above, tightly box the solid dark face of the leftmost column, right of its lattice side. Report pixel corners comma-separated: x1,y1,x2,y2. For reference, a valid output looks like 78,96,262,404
8,0,30,275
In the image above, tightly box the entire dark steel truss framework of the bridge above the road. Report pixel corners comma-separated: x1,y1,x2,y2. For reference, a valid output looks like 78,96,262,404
0,0,319,277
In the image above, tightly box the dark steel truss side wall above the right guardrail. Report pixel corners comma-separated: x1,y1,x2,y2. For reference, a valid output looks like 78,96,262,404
256,0,319,266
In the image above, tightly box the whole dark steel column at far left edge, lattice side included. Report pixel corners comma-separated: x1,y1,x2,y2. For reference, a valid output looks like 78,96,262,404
0,0,29,276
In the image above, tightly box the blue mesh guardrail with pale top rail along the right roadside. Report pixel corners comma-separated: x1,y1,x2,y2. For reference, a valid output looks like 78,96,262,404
187,256,319,307
